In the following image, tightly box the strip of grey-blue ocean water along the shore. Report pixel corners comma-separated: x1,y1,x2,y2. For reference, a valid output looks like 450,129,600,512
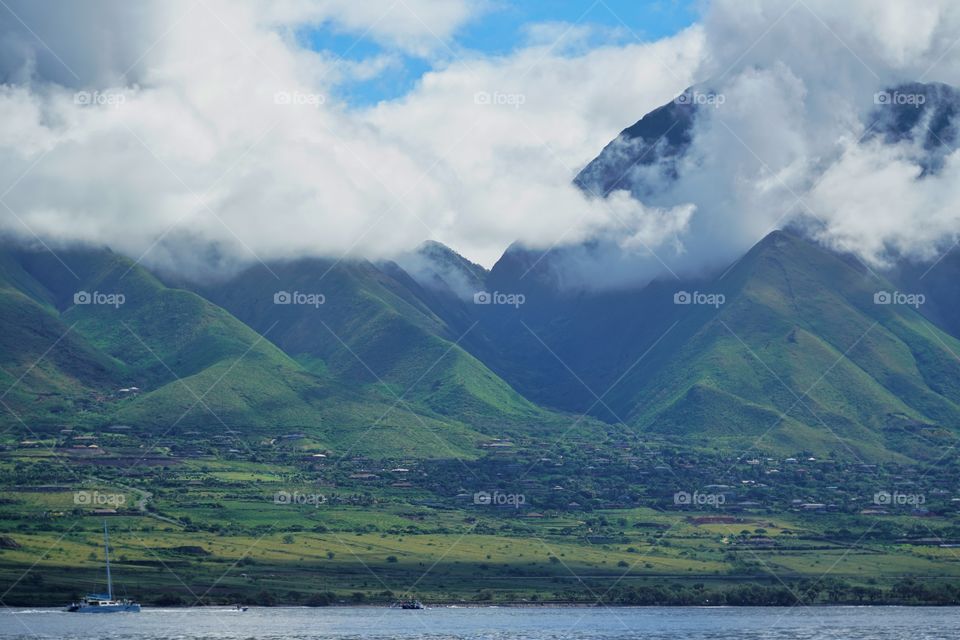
0,607,960,640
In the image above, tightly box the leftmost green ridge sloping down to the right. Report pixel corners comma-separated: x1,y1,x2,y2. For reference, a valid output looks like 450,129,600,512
0,245,492,457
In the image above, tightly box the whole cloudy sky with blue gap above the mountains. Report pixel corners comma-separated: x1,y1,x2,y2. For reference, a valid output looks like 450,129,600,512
0,0,960,287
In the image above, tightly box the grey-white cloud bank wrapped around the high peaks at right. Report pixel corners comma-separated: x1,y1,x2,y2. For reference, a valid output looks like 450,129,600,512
554,0,960,287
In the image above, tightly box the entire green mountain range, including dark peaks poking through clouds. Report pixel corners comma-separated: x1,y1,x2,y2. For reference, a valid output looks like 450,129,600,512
0,85,960,461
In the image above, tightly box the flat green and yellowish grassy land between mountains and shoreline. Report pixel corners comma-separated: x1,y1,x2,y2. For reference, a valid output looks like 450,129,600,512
0,436,960,605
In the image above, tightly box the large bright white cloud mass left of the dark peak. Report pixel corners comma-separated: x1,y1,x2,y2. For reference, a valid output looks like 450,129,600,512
0,0,700,276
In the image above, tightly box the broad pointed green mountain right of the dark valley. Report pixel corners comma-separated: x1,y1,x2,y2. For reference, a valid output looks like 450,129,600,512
616,232,960,457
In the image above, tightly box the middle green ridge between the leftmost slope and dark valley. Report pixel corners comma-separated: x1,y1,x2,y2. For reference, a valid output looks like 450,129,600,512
200,259,568,433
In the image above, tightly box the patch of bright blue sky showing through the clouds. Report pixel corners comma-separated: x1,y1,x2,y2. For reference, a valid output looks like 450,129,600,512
303,0,697,106
